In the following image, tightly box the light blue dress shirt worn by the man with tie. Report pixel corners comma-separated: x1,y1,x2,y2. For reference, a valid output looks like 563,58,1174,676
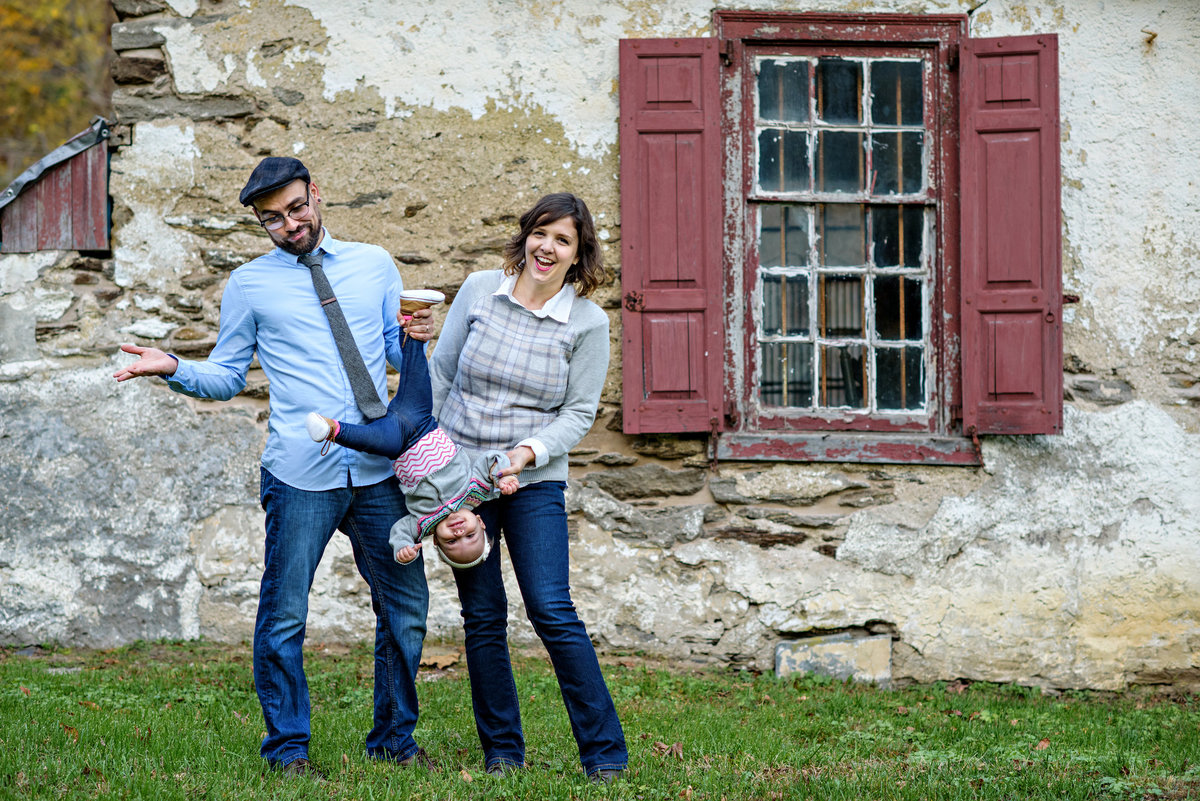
167,229,403,490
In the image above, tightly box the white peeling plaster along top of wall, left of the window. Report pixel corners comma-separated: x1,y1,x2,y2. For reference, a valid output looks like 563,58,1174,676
280,0,712,157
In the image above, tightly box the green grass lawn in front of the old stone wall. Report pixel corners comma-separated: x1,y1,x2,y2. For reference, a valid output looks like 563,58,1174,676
0,643,1200,801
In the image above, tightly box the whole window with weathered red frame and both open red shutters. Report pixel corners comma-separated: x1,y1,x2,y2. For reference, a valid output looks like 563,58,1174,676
620,12,1062,464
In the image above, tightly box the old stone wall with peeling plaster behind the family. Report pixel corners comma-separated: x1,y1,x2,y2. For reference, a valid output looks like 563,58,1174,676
0,0,1200,688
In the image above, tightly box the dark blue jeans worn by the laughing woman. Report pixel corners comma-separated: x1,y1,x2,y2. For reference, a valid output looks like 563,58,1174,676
455,481,629,773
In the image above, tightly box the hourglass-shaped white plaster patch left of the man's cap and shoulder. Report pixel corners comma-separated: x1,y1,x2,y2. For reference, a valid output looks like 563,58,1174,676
110,122,200,289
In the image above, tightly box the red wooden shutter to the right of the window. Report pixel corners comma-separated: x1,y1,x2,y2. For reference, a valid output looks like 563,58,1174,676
961,35,1062,434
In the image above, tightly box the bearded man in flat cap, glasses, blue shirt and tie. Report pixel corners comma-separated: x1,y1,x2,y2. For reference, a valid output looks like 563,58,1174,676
114,157,432,777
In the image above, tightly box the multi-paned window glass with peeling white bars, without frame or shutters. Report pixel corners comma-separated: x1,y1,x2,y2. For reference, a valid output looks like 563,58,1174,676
746,48,936,420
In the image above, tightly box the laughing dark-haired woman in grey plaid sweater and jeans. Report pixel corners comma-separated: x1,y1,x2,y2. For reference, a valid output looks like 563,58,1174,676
431,193,629,783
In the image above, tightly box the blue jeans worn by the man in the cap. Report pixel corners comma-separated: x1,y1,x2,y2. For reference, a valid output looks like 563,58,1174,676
254,470,430,765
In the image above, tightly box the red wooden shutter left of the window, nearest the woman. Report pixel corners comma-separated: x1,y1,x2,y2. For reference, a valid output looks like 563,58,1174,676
620,38,725,434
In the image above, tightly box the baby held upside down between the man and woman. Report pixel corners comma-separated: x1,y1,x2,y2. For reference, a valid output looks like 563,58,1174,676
305,290,520,570
